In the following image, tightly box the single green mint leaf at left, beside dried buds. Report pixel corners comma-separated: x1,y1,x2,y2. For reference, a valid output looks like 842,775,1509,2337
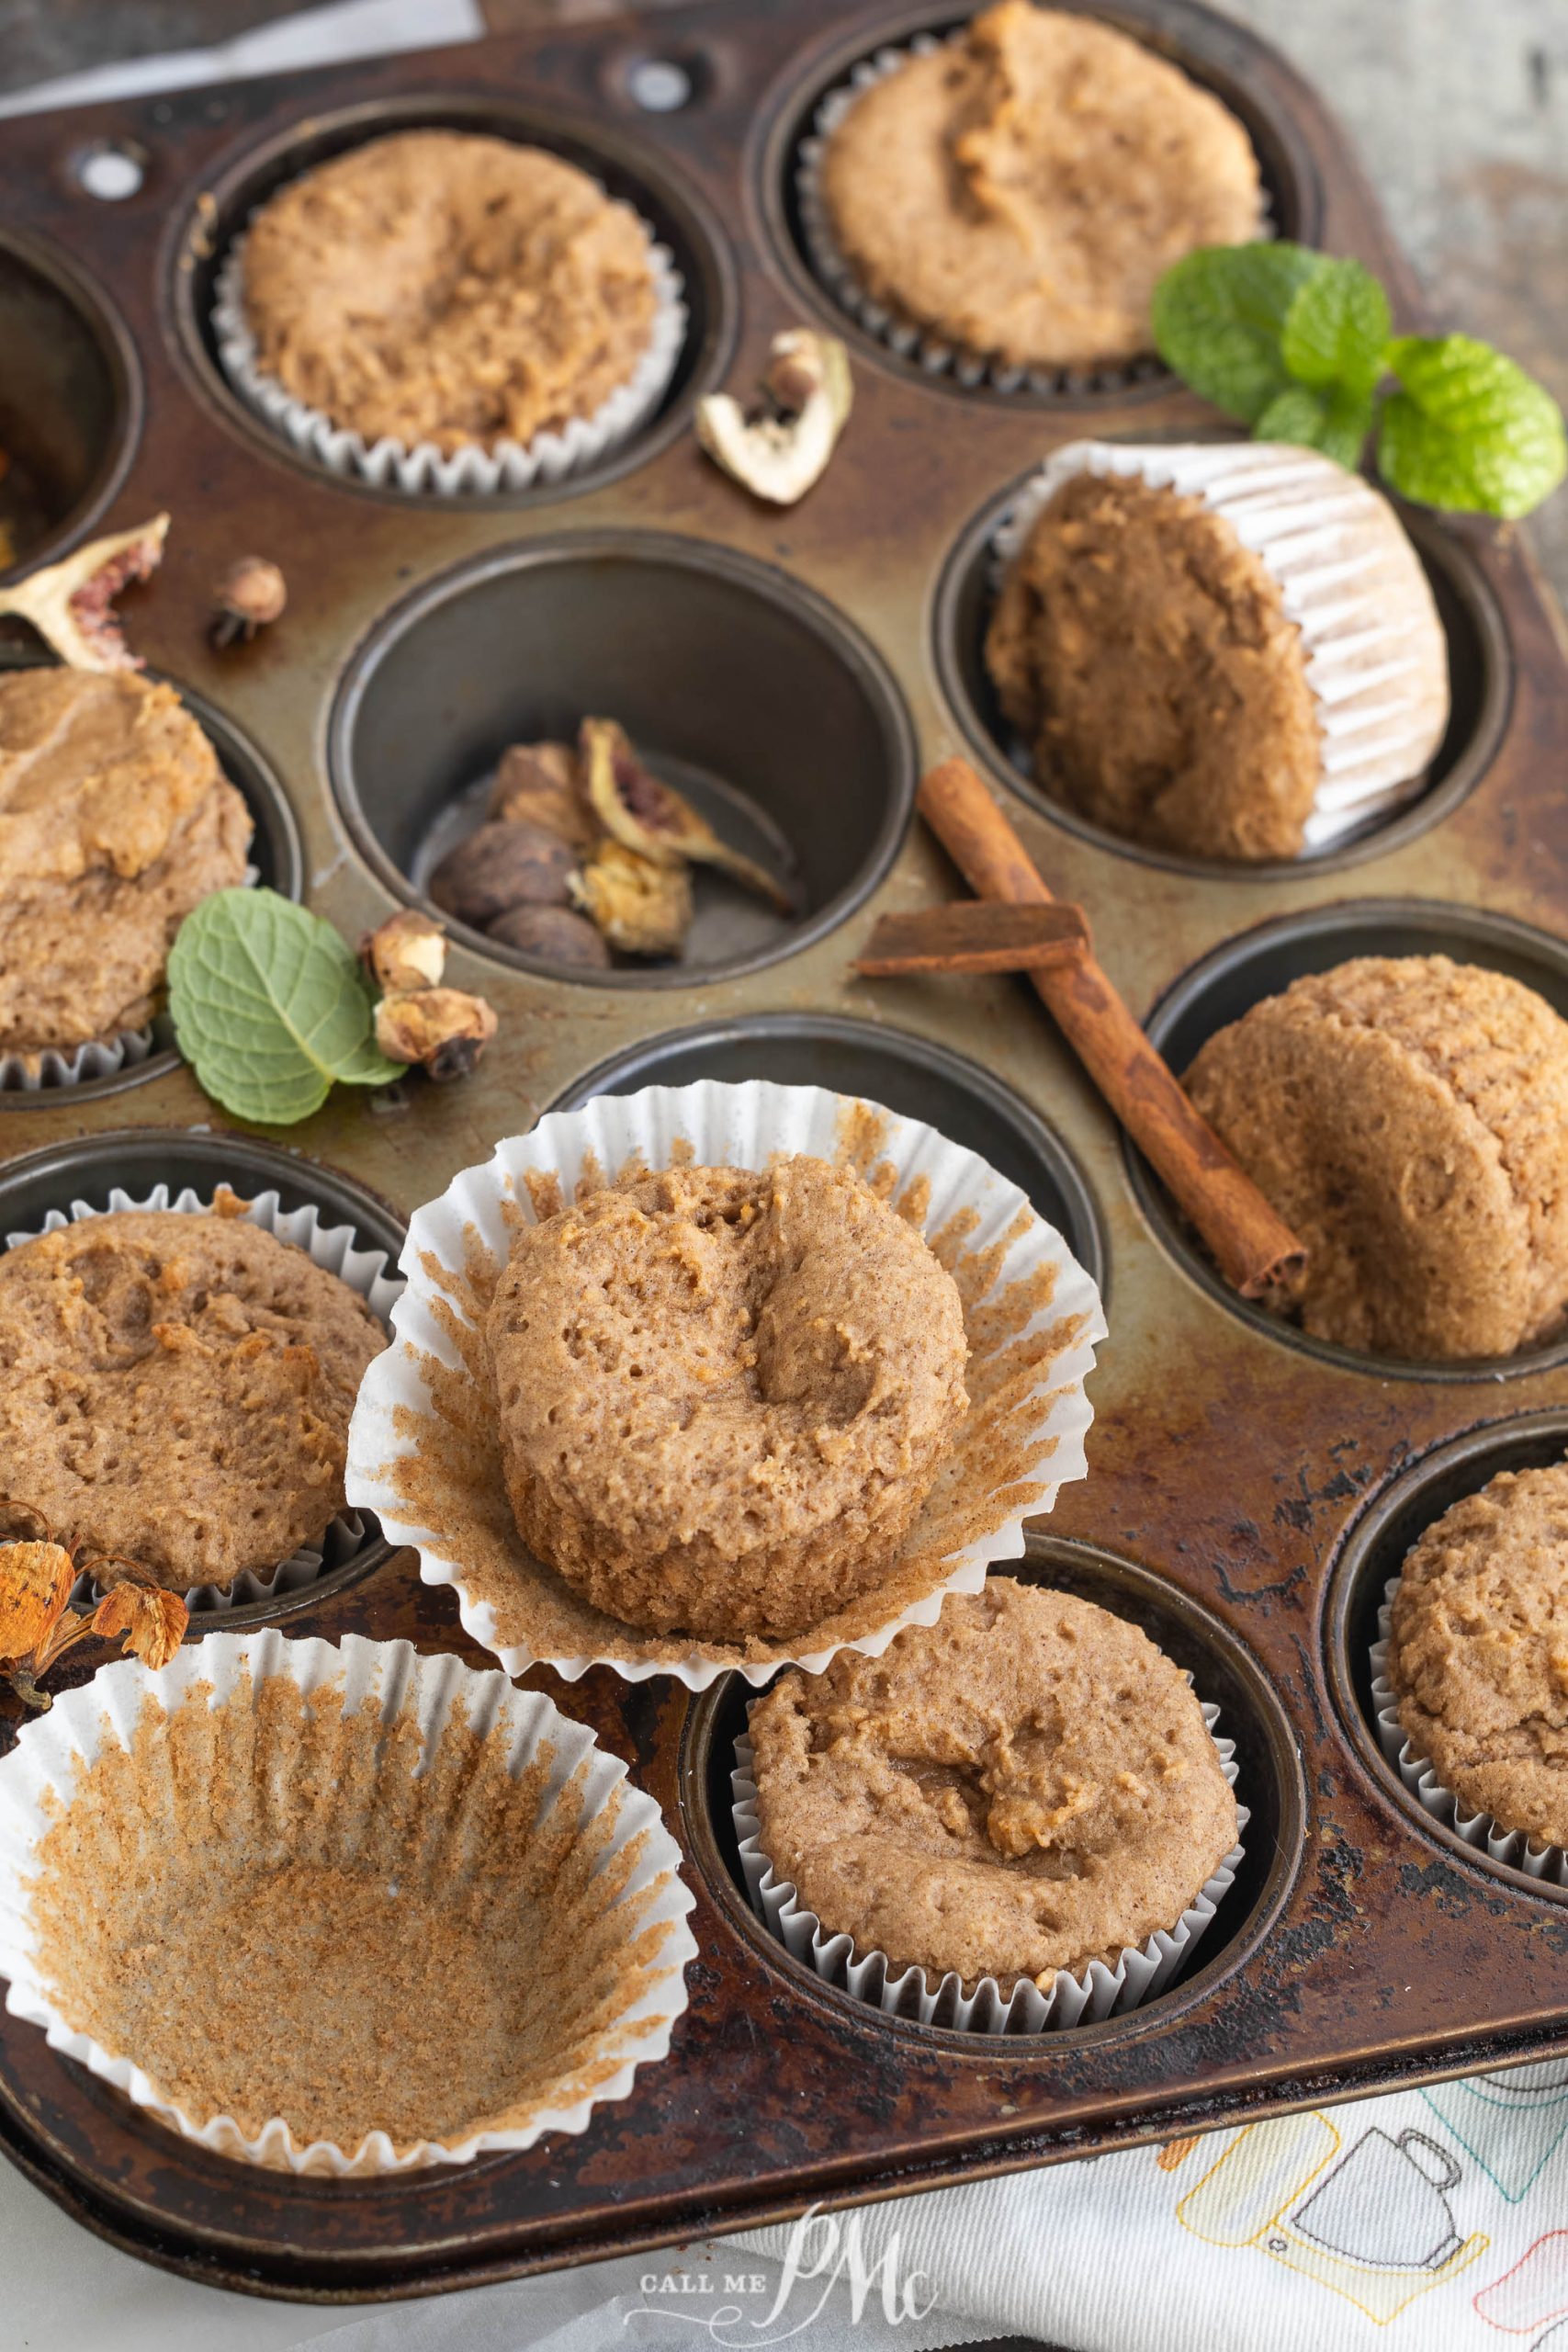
169,889,407,1126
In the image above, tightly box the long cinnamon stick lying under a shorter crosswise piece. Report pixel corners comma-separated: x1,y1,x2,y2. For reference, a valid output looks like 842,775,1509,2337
919,760,1307,1298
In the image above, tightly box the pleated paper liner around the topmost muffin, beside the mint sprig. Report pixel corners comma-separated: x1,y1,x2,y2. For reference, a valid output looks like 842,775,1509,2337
795,28,1274,398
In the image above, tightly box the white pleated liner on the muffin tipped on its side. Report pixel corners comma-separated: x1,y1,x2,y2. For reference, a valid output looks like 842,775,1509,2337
992,440,1448,856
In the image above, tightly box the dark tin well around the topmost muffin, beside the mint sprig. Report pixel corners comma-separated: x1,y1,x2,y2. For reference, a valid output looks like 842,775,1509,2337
757,0,1324,409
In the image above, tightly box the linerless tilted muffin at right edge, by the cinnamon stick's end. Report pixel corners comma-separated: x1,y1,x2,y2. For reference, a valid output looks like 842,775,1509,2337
1185,955,1568,1362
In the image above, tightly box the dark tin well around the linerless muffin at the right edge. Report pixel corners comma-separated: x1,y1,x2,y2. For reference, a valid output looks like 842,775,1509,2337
1122,899,1568,1381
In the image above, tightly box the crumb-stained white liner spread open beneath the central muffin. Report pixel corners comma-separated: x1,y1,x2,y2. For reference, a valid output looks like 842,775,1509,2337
345,1080,1105,1691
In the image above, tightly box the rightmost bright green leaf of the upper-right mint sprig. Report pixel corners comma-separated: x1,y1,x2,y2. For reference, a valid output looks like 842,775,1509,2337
1378,334,1568,517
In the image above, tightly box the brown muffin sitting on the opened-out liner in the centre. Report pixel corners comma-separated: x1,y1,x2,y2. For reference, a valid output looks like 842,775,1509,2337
487,1155,968,1639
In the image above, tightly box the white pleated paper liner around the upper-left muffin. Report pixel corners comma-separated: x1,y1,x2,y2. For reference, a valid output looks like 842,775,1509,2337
211,206,686,499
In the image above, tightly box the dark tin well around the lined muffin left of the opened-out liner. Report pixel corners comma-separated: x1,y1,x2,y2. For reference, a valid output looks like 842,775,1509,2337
0,1126,404,1642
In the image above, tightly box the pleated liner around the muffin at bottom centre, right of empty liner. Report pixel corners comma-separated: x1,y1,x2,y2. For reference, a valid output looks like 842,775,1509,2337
728,1705,1251,2034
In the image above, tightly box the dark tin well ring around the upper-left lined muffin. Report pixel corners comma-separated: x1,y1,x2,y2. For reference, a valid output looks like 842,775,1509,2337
169,92,736,505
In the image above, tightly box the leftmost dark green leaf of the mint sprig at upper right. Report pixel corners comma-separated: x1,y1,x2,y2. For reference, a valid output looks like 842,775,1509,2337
1152,244,1331,425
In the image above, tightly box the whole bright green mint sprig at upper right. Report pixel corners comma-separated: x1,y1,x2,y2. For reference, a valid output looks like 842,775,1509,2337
1152,244,1568,517
